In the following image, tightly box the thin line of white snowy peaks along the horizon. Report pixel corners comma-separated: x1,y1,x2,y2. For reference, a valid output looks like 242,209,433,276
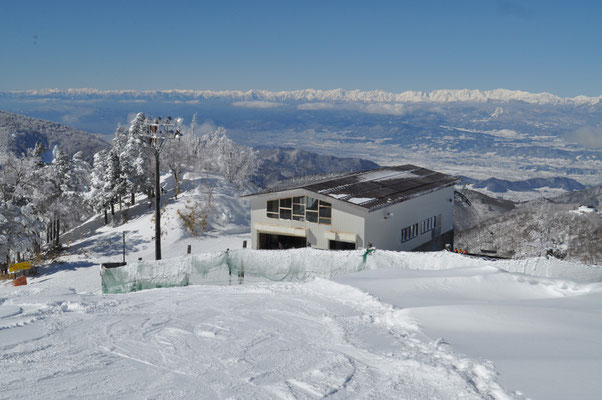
0,88,602,107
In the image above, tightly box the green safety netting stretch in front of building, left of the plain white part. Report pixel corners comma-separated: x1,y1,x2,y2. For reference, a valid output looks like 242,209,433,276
101,249,372,293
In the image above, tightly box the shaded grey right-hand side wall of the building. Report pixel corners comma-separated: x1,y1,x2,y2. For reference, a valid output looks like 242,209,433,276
365,186,454,251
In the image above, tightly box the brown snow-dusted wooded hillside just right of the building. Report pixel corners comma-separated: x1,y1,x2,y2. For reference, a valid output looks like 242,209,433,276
454,186,602,265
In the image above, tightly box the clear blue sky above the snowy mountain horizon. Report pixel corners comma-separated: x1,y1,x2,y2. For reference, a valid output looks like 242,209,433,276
0,0,602,96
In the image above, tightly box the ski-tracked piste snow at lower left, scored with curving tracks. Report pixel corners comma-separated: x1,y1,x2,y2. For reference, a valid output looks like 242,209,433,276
0,271,508,399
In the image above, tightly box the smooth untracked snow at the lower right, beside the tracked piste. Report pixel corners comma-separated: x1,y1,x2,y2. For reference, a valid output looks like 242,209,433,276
334,263,602,399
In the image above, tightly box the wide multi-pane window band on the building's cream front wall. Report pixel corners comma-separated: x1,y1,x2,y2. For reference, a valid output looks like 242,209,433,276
266,196,332,225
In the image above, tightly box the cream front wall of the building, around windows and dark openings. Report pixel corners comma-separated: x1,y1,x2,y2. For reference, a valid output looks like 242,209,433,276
251,191,367,249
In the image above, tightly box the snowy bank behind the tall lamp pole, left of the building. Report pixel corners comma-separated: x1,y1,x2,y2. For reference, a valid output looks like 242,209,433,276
61,174,250,264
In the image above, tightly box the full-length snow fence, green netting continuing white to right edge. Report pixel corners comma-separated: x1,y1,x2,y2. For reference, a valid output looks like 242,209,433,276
101,248,602,293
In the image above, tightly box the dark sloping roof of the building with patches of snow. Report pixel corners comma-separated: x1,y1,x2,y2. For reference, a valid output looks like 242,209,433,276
243,164,458,211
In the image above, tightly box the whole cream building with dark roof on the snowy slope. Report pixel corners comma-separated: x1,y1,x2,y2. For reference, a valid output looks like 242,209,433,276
245,165,458,251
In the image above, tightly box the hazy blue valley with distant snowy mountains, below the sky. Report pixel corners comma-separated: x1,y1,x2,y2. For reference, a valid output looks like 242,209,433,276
0,89,602,201
